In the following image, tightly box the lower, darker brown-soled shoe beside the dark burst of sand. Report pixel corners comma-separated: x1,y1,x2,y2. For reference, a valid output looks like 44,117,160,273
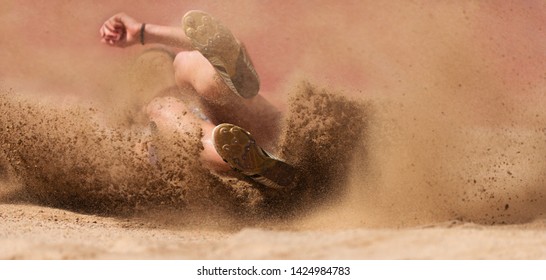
212,124,296,189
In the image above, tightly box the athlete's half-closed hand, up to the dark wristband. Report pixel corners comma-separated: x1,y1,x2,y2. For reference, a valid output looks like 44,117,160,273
100,13,142,48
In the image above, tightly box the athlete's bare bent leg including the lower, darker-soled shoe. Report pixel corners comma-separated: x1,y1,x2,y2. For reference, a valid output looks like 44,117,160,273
174,51,297,190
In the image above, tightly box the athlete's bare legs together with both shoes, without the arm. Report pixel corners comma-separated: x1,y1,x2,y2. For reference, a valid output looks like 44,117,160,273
166,11,297,189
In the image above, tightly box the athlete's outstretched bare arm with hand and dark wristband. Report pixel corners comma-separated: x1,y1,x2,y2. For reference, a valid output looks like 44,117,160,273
99,13,192,50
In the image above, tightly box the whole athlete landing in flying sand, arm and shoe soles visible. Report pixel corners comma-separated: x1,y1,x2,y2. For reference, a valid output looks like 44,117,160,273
100,10,297,189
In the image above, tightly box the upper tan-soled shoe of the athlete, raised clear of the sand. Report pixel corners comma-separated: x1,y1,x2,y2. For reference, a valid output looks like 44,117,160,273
182,10,260,98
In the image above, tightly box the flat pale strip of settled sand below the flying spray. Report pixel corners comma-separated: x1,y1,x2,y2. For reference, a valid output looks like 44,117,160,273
0,202,546,260
